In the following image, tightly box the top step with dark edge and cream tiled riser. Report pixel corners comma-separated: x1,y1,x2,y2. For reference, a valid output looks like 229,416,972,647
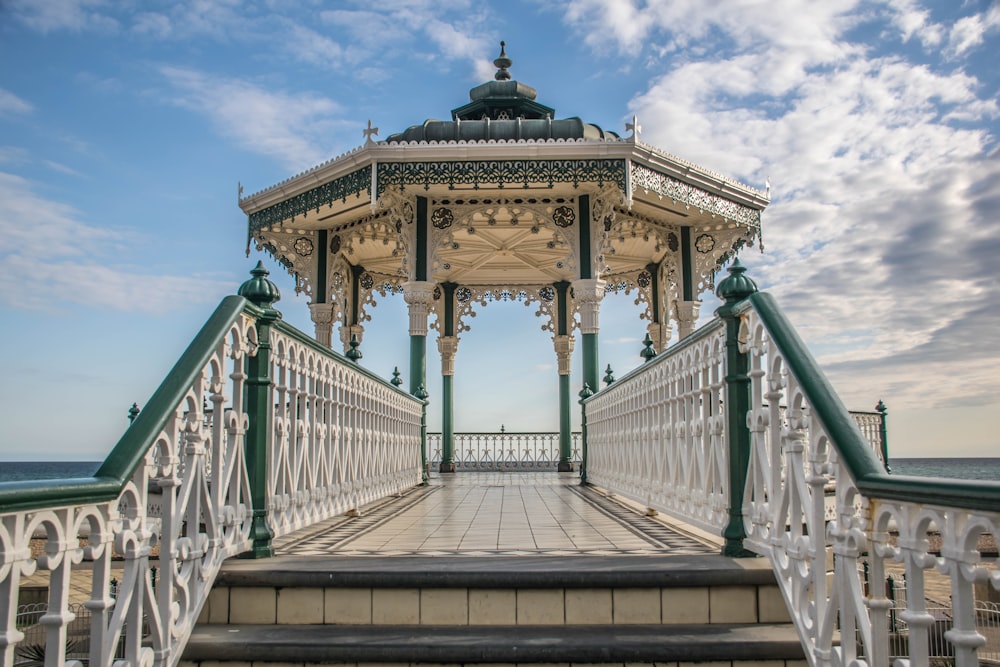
199,555,789,626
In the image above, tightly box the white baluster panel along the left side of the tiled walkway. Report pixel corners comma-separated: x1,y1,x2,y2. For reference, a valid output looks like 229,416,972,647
268,327,421,537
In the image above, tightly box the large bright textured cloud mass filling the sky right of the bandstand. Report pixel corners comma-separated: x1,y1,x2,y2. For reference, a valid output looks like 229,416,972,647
566,0,1000,408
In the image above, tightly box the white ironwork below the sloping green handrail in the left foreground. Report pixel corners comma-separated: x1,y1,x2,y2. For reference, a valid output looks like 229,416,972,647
0,315,257,665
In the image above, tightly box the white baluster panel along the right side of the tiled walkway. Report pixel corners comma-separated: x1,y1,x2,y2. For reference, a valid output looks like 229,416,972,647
586,320,729,534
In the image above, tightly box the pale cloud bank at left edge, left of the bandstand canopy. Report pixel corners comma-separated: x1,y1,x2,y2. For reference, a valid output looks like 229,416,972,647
0,172,232,314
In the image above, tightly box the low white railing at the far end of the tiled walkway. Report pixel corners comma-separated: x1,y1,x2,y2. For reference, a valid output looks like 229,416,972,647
427,431,581,472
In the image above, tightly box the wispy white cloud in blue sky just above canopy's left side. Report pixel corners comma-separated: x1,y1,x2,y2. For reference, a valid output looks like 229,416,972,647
160,67,339,171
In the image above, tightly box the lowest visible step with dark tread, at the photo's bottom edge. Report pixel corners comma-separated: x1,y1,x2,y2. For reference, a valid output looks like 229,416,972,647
181,624,806,667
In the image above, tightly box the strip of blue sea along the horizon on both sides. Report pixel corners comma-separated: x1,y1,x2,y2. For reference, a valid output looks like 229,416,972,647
0,458,1000,482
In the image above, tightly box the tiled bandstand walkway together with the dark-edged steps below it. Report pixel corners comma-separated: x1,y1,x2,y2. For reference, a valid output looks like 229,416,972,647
182,472,806,667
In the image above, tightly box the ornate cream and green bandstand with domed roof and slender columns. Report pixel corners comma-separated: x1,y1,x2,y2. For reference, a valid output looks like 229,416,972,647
240,42,768,472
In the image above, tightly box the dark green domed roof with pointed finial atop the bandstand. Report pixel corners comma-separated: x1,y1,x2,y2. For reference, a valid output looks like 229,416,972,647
386,42,619,144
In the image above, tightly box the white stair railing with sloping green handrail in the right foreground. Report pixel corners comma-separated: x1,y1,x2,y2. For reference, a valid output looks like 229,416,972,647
740,294,1000,666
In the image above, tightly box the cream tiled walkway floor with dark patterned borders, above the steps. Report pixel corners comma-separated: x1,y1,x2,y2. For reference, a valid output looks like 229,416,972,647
277,472,718,556
